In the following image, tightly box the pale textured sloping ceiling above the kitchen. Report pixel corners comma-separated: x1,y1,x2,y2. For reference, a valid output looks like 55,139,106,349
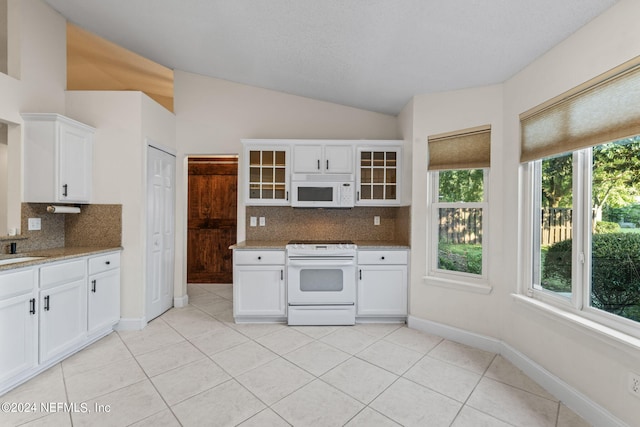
45,0,617,114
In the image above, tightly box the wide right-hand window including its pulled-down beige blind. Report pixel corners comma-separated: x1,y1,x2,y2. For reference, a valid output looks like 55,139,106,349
521,57,640,336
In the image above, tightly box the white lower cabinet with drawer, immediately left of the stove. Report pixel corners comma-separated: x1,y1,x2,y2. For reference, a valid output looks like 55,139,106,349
233,249,287,322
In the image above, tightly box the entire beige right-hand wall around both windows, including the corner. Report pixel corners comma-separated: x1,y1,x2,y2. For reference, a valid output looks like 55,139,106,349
408,0,640,425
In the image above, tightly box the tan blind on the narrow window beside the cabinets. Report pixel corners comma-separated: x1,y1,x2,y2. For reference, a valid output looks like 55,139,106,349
428,125,491,170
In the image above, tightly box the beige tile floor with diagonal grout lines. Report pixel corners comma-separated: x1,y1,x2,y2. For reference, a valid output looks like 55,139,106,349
0,285,588,427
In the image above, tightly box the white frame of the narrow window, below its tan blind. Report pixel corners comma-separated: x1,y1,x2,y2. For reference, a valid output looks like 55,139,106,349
424,167,491,293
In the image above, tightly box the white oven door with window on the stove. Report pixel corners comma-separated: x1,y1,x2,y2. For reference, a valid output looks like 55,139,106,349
287,257,356,305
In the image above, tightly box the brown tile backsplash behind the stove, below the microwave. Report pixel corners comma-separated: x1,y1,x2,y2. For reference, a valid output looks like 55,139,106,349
246,206,410,244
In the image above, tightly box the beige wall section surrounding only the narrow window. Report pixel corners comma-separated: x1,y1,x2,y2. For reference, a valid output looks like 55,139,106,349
403,85,503,337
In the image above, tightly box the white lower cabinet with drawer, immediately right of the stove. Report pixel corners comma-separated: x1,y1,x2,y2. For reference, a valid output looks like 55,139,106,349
356,250,408,320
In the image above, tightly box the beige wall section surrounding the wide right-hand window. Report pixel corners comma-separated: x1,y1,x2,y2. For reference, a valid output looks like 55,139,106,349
500,0,640,425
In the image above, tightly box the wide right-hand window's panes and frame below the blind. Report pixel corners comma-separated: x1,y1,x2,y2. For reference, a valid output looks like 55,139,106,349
532,136,640,332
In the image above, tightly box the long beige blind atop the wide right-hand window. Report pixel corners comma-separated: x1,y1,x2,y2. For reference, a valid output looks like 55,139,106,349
520,57,640,162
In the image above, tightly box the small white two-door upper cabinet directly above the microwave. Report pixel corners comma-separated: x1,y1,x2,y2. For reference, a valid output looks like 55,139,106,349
293,141,354,174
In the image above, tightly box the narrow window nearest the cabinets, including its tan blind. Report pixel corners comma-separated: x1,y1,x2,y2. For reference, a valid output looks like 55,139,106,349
427,126,491,284
